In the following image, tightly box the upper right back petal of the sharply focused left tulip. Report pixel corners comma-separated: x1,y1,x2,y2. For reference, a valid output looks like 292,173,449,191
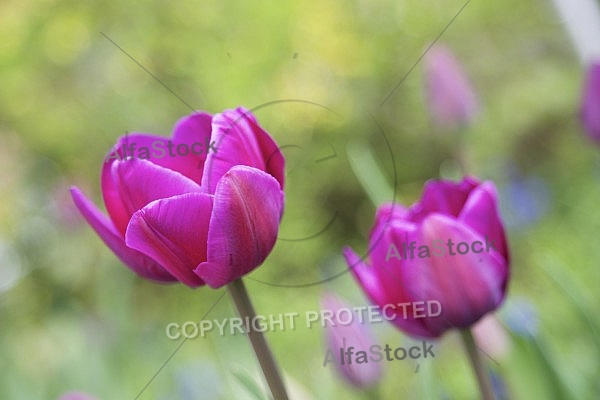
202,107,285,193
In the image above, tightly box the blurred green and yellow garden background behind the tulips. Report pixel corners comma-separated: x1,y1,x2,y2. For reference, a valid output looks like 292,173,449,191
0,0,600,399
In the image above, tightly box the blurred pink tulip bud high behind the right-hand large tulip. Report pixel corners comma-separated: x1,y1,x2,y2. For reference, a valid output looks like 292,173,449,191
424,45,479,128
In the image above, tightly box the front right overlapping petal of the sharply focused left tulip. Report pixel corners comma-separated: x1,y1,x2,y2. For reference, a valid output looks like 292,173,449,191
195,166,284,288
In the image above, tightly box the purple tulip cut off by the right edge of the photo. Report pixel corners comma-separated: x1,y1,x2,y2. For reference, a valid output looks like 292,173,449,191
581,61,600,143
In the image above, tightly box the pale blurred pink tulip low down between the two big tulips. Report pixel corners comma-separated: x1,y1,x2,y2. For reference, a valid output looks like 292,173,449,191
321,293,382,388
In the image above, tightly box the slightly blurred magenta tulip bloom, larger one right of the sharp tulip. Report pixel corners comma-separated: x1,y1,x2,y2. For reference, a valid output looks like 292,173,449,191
344,178,509,337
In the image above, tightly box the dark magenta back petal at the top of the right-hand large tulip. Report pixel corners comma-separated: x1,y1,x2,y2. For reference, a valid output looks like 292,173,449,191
409,177,479,222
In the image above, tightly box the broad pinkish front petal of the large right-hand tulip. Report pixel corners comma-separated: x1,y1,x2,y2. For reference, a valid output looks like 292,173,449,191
418,214,508,334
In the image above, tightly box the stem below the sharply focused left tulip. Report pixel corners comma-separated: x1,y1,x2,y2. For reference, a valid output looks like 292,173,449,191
229,279,288,400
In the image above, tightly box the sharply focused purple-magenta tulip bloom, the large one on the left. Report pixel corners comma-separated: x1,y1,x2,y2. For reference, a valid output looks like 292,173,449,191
71,108,285,288
